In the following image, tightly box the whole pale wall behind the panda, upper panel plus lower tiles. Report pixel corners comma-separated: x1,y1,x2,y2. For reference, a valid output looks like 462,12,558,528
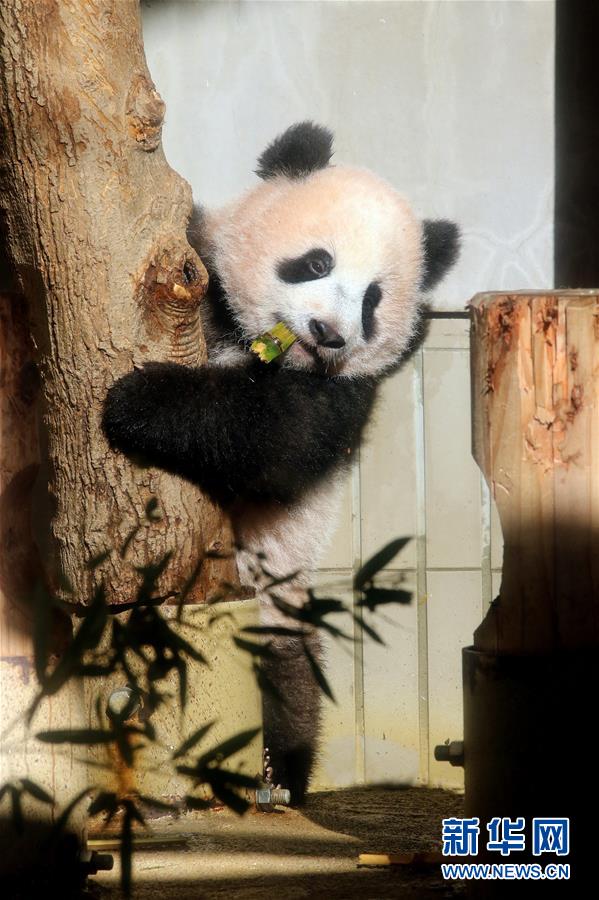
143,0,554,786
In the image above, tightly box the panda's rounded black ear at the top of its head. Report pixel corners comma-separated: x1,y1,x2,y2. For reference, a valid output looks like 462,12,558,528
256,122,333,178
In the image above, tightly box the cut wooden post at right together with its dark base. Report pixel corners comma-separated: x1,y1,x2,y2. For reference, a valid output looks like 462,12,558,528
462,291,599,897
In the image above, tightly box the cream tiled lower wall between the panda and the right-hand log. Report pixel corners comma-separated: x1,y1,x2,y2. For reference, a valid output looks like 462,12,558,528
316,317,502,787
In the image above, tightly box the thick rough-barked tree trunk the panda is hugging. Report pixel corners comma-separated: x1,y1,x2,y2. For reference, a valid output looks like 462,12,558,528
0,0,239,601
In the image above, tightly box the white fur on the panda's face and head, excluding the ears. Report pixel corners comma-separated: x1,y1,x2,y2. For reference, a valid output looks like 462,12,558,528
202,166,423,375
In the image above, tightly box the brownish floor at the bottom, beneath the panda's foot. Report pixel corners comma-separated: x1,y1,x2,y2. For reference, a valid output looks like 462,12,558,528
93,788,462,900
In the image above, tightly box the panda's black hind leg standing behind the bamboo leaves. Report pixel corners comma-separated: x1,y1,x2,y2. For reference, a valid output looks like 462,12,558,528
262,632,322,806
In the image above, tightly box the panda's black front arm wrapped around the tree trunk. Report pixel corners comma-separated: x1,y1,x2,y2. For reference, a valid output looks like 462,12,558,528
103,363,376,503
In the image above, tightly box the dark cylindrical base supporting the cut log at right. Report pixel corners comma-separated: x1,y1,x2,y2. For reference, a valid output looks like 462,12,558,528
462,647,599,897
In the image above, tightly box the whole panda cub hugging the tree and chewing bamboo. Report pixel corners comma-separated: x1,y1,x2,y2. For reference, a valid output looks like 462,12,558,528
104,122,459,804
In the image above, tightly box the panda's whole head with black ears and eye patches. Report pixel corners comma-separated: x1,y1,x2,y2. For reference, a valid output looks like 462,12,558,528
202,122,459,375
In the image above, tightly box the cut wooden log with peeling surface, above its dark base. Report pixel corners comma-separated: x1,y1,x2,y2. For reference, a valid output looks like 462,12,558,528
471,291,599,654
